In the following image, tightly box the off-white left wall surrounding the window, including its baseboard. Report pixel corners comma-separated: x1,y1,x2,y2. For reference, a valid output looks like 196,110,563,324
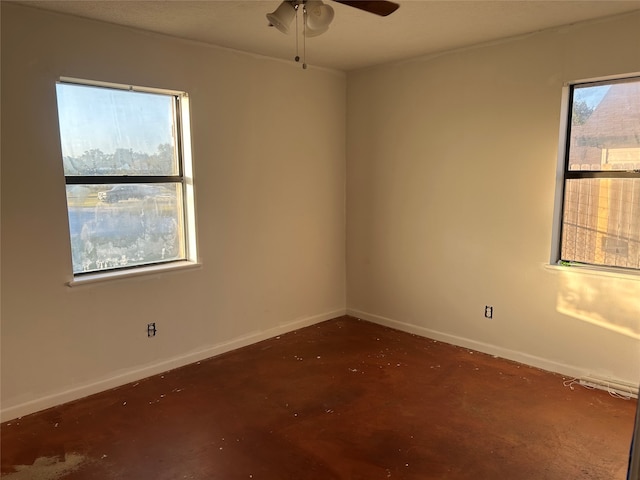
1,2,346,420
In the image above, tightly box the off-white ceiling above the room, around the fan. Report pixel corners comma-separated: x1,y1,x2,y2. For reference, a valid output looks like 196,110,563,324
12,0,640,71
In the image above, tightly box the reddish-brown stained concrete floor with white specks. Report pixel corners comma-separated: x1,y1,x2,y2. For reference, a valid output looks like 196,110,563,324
1,317,636,480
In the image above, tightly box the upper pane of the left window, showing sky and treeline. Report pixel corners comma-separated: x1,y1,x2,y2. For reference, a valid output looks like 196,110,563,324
56,83,179,176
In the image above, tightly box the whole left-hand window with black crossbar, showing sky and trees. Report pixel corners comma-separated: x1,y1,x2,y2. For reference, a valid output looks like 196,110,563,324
56,79,195,278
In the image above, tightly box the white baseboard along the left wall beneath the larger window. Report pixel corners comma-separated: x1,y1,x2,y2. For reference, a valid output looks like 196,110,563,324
0,309,346,422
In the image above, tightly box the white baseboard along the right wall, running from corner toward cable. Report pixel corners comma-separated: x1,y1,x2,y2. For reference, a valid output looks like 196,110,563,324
347,308,590,378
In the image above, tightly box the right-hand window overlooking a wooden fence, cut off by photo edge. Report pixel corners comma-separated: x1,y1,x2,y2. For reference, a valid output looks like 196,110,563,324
552,77,640,271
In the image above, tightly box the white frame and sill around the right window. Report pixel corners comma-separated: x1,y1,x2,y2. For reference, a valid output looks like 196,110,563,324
549,72,640,280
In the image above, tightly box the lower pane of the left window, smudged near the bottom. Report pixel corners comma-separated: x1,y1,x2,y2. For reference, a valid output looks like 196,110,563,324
67,183,185,273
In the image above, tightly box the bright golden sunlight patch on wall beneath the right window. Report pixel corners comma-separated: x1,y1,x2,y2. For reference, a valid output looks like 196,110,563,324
557,272,640,340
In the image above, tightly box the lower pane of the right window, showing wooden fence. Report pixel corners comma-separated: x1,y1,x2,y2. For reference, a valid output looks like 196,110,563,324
561,178,640,268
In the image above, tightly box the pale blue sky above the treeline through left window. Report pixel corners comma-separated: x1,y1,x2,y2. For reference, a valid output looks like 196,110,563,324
56,83,174,158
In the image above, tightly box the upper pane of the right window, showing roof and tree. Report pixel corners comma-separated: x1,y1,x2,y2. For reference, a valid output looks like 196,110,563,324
569,80,640,171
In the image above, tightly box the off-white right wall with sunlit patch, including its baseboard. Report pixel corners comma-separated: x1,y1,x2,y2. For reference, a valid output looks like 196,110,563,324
347,12,640,385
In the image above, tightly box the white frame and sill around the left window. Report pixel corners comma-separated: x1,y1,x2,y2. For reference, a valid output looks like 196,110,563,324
58,77,199,287
